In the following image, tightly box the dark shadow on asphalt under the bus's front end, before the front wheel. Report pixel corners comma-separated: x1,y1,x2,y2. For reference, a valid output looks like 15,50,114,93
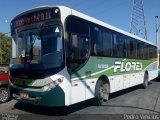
14,100,93,116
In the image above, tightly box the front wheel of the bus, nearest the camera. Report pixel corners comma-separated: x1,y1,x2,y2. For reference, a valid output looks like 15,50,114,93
95,80,109,106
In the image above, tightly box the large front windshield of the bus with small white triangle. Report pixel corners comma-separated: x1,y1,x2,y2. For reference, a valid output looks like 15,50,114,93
11,25,64,69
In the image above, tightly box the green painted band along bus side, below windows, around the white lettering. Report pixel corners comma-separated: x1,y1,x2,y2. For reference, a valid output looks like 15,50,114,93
71,56,157,80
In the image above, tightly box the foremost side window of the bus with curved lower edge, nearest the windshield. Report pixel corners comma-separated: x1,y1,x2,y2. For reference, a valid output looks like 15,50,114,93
69,34,89,71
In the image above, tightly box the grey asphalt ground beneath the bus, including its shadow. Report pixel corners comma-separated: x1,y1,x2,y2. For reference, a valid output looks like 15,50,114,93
0,80,160,120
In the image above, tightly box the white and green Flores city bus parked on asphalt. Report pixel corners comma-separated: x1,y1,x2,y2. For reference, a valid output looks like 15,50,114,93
10,6,158,107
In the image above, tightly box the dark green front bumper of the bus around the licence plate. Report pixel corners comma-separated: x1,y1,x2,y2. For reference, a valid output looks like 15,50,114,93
10,86,65,107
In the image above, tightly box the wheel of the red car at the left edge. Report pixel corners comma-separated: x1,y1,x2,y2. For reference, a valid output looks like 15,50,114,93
0,87,10,104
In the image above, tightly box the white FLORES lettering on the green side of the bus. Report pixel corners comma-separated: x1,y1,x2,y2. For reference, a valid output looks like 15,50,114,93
114,61,143,72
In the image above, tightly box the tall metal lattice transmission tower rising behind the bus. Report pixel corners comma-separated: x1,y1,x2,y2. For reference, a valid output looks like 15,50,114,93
130,0,148,40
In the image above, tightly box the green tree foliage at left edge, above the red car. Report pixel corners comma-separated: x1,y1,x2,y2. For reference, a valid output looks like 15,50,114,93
0,32,11,64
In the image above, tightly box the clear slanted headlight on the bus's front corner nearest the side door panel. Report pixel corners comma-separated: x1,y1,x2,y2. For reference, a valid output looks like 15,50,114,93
41,77,64,91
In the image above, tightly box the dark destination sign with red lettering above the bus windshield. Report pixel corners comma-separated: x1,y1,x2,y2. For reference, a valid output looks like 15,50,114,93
11,8,60,28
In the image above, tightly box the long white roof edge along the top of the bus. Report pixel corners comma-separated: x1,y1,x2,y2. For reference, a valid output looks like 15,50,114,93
12,5,156,46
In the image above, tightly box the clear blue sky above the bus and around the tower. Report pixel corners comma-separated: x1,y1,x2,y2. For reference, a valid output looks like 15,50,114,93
0,0,160,46
